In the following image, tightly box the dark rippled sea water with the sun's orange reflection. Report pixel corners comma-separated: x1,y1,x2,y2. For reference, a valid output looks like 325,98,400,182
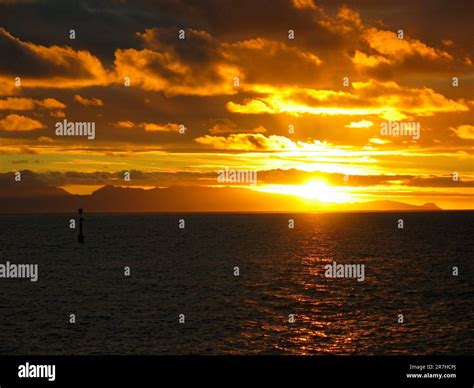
0,212,474,355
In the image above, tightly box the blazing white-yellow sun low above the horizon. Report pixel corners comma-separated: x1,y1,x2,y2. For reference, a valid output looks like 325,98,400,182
257,181,352,203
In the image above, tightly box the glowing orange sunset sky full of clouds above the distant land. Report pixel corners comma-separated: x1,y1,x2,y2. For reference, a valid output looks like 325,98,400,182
0,0,474,209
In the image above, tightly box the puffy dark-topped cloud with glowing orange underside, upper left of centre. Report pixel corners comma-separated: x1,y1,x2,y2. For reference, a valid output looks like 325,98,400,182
114,28,243,96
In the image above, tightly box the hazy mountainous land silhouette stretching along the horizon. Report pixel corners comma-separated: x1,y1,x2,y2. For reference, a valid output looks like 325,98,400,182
0,182,442,214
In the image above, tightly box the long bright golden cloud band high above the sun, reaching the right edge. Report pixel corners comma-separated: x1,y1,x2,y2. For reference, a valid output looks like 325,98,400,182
226,80,469,120
